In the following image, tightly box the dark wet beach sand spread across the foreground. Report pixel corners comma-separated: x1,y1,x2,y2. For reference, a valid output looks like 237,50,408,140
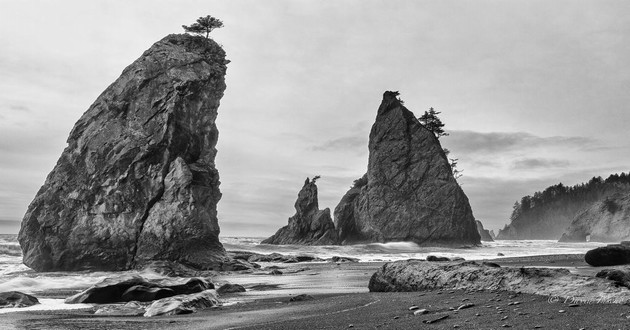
0,255,630,330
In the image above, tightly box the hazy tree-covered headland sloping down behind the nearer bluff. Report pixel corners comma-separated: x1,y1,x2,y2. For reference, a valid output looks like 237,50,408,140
496,173,630,240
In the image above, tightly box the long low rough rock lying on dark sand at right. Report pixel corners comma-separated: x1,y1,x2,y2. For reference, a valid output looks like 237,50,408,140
368,261,630,304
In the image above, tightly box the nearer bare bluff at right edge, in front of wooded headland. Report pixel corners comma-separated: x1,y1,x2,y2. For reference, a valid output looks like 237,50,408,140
560,193,630,242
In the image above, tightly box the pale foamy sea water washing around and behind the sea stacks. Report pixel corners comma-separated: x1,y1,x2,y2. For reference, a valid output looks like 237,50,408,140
0,234,606,314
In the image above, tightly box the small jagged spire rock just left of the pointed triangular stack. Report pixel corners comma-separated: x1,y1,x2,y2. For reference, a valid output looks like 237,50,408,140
261,178,338,245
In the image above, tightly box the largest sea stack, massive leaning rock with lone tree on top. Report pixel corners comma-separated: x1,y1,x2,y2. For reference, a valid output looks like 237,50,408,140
19,35,229,271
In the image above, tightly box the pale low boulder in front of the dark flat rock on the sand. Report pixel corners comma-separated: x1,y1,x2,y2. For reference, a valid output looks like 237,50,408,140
144,290,219,317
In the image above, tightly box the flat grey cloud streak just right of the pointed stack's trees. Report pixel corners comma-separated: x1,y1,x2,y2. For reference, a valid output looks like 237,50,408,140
446,130,597,153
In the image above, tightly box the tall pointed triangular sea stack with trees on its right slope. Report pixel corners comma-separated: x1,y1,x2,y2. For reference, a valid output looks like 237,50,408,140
335,92,480,246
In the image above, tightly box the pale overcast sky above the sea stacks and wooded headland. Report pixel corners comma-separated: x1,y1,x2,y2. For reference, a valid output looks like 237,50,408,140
0,0,630,236
